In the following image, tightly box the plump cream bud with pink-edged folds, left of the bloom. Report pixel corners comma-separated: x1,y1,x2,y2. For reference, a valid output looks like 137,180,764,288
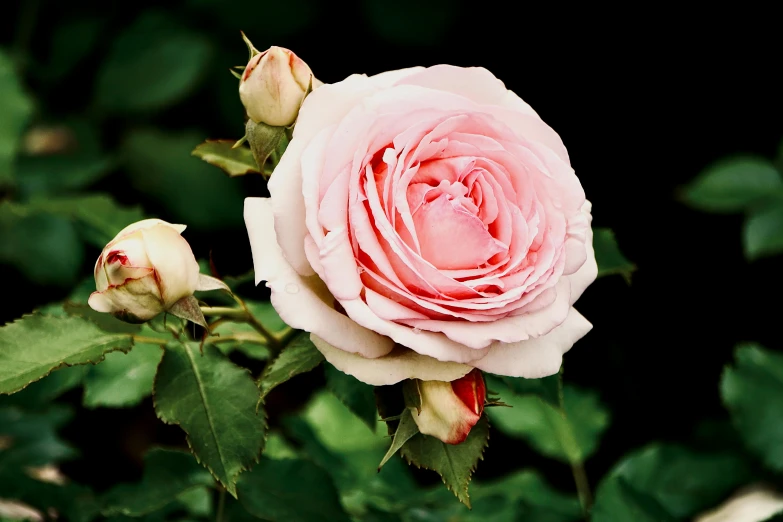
89,219,199,322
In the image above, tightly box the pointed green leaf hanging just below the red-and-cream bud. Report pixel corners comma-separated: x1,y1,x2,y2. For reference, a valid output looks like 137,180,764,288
401,417,489,507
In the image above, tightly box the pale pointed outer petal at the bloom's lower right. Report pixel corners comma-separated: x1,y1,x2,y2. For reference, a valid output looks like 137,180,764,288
471,308,593,379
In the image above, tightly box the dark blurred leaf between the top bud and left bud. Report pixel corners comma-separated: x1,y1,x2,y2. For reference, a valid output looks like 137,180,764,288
122,129,244,230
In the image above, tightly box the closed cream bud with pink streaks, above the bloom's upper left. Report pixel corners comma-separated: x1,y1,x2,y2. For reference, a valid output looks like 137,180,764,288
239,46,321,127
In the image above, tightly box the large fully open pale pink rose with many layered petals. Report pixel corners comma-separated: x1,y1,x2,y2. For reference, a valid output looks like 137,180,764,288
245,65,597,386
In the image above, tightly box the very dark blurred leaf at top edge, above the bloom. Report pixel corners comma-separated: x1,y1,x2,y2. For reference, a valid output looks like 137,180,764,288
366,0,459,46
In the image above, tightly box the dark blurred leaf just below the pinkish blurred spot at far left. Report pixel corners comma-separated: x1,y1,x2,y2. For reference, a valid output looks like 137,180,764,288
16,154,115,198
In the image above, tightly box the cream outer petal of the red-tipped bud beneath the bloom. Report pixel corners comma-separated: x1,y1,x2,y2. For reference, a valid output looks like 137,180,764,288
413,381,483,444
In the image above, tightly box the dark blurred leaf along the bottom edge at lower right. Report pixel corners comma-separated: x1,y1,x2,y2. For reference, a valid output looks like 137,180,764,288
600,444,752,519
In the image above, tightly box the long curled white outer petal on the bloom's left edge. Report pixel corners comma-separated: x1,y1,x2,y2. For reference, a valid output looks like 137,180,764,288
245,198,394,359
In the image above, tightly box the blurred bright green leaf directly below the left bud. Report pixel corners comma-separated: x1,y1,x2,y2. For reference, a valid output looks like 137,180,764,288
83,344,163,408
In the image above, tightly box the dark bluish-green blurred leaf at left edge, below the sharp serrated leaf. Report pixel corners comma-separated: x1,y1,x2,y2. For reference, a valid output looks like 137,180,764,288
0,406,77,470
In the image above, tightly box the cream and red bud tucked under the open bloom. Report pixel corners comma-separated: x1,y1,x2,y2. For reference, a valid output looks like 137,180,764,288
413,369,487,444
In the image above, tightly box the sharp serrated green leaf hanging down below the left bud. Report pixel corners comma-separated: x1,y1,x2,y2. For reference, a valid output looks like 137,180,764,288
155,343,266,496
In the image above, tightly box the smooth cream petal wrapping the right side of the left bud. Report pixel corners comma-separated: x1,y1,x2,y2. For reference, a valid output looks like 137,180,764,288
141,225,199,308
